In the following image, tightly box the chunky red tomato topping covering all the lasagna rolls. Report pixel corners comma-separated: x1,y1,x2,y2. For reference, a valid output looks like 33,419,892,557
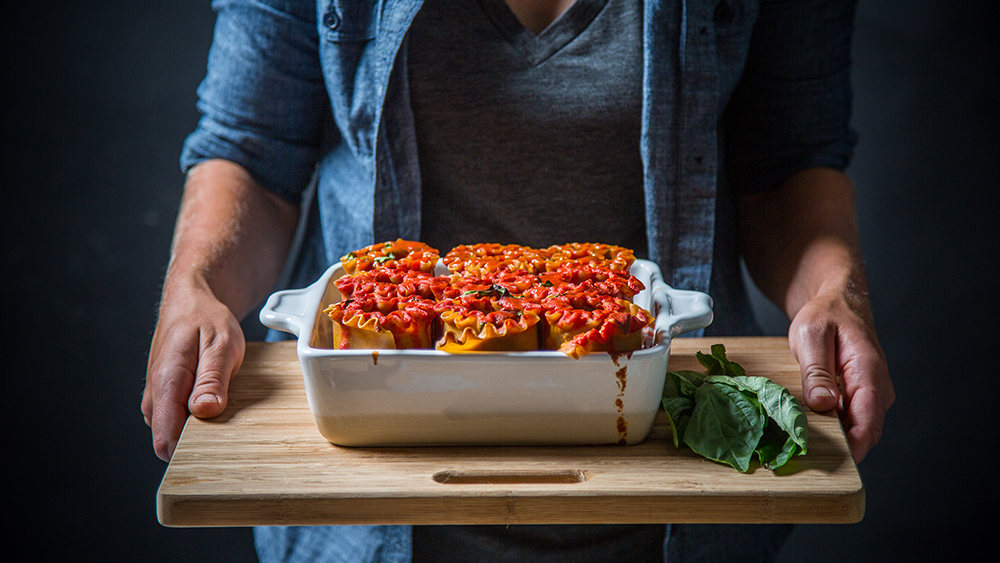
324,239,653,357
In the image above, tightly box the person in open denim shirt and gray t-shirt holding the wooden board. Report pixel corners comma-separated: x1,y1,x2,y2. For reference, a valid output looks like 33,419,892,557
142,0,894,561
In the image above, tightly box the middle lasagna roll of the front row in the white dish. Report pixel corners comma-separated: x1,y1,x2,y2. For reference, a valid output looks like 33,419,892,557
435,287,541,354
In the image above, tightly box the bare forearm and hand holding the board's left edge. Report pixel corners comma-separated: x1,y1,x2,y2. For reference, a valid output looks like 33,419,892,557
142,160,299,461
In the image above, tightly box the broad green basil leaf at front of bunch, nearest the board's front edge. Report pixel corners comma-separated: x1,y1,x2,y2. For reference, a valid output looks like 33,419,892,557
684,379,766,473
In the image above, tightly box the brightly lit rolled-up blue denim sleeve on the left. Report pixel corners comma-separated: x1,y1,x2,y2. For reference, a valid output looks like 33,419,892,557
181,0,329,201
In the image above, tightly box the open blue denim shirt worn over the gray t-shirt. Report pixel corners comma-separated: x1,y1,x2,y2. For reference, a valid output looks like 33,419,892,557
181,0,855,561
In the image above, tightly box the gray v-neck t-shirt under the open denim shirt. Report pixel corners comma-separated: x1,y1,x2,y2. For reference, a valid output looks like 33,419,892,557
407,0,646,256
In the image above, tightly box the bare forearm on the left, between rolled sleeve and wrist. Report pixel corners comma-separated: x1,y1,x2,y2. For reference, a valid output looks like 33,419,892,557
164,160,299,318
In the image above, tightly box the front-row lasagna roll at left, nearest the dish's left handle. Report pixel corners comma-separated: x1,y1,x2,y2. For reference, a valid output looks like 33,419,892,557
323,295,437,350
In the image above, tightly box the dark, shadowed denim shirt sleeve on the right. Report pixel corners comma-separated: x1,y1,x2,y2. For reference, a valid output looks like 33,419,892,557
724,0,857,191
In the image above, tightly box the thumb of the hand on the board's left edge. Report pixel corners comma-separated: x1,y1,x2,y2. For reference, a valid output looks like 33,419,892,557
188,329,246,418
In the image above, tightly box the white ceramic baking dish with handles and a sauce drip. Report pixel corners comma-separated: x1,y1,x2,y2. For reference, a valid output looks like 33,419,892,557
260,260,712,446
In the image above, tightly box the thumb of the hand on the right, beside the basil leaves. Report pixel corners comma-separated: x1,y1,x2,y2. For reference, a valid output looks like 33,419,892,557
789,323,842,412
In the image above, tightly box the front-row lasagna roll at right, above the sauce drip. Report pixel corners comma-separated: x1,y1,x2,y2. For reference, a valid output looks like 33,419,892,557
542,293,653,358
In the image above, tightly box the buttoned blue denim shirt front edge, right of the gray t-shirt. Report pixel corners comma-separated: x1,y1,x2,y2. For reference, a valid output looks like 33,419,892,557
643,0,719,300
